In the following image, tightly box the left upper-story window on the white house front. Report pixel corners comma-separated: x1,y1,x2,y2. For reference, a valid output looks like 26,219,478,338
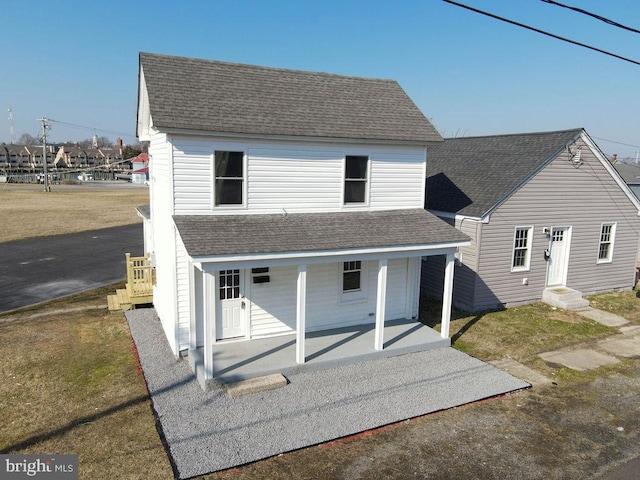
214,151,244,206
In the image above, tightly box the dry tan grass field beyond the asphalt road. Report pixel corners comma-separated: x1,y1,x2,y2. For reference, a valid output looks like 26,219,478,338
0,184,149,243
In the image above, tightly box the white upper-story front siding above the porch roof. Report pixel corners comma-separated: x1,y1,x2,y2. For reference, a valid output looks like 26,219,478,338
172,136,425,215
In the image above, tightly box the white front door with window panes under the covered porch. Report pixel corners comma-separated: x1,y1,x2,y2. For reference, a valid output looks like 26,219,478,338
216,270,246,340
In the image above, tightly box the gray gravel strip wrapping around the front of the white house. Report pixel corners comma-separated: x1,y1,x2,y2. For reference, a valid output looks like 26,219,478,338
127,309,529,478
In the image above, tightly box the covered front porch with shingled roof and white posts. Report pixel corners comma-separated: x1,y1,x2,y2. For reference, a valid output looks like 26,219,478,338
174,209,468,388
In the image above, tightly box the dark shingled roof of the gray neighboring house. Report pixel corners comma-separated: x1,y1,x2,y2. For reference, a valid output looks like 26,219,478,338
426,128,583,217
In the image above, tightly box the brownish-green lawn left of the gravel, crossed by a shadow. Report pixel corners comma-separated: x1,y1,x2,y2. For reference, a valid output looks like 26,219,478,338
0,302,172,478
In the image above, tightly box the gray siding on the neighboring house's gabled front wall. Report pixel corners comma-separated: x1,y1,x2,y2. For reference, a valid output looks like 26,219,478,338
473,144,640,310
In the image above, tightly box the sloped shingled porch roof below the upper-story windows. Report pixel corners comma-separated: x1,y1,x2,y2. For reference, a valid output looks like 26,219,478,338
173,209,469,257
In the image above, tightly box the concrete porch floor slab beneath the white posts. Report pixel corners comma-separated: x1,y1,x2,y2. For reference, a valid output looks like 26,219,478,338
188,319,451,384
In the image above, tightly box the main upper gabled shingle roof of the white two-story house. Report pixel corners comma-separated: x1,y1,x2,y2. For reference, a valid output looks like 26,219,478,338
140,53,442,143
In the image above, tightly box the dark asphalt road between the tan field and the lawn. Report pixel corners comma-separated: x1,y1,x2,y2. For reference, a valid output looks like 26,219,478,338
0,224,144,313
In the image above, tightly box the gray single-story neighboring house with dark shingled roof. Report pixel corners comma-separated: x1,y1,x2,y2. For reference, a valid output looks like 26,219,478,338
422,128,640,311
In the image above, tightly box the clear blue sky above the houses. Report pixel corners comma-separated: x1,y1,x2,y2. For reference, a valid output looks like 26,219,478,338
0,0,640,157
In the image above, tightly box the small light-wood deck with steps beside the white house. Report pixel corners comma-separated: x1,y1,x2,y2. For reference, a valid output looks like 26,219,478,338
107,253,156,311
